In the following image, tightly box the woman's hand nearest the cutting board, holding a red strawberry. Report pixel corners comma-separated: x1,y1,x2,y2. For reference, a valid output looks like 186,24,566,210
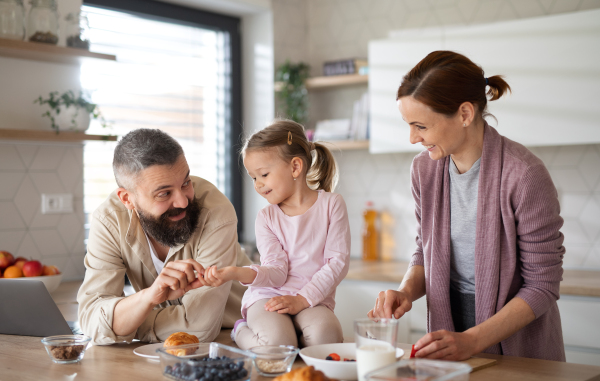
415,330,479,361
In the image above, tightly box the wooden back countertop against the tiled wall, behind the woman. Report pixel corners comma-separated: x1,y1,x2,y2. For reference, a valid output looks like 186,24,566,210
346,260,600,297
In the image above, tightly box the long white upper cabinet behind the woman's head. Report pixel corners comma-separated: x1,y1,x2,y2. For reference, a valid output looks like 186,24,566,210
369,10,600,153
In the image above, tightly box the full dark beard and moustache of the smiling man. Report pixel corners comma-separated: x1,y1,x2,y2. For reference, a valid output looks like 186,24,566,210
137,196,200,247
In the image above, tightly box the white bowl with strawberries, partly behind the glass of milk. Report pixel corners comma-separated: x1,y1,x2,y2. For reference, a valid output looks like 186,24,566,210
300,343,404,381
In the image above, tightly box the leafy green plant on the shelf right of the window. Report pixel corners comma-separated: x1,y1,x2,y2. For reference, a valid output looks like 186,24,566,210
275,61,310,125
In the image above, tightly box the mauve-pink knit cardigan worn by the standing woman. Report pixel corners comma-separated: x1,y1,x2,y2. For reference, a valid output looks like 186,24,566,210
410,124,565,361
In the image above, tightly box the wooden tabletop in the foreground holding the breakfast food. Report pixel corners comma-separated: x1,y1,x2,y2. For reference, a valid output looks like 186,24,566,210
0,282,600,381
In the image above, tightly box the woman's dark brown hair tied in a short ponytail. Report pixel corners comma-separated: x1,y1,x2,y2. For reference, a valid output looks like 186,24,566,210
396,50,511,117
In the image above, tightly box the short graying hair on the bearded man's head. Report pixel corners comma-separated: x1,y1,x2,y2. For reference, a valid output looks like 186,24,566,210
113,128,183,192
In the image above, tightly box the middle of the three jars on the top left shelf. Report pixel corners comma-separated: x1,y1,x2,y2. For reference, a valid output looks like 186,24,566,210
27,0,58,45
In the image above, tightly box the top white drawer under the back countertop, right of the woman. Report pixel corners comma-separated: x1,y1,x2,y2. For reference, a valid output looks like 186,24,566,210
558,295,600,348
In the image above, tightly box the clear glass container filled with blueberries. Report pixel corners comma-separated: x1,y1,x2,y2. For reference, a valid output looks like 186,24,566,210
156,343,253,381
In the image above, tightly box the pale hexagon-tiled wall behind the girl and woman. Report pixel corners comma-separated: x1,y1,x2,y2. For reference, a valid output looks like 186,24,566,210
273,0,600,270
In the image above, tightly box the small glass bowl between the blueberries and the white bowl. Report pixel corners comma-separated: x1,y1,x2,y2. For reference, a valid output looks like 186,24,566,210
250,345,299,377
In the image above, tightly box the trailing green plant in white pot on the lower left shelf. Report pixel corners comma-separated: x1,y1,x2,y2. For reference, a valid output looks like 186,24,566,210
33,90,108,134
